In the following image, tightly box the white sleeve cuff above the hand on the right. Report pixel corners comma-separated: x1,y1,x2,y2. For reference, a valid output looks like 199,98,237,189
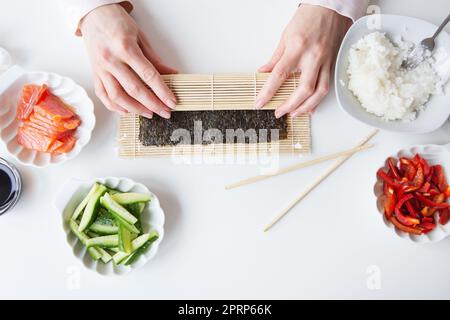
300,0,369,21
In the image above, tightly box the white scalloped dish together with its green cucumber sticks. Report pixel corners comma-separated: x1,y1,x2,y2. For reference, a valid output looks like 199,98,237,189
55,177,165,275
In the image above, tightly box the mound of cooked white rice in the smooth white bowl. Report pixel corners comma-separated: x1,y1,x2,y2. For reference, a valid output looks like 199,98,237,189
347,32,442,121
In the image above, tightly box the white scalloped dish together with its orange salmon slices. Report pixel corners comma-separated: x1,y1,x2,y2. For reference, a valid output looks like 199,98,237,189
0,66,95,167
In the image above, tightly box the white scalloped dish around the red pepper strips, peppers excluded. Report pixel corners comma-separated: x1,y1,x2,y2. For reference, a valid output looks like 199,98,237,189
374,144,450,243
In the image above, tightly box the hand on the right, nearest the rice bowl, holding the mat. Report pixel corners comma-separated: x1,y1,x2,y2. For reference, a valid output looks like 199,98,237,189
256,4,351,118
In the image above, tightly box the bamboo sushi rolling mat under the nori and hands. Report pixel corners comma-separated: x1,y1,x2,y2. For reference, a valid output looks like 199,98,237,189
118,73,311,158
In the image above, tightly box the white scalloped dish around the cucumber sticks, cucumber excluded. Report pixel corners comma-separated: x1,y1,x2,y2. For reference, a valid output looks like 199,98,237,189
55,177,165,275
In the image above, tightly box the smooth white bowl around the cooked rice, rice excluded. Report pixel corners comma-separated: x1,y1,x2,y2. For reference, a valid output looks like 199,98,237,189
335,14,450,133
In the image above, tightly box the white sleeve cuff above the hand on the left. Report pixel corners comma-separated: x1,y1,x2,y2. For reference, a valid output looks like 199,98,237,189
58,0,133,36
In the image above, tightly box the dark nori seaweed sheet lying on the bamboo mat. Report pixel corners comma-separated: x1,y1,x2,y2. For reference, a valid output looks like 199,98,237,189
139,110,288,146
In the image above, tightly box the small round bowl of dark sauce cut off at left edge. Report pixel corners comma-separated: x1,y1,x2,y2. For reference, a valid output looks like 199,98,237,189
0,158,22,216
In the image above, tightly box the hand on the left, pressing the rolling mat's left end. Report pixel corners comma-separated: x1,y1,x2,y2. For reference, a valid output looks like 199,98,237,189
80,4,176,119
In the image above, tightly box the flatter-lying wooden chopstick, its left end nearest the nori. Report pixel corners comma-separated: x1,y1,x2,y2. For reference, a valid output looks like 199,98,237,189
225,144,373,190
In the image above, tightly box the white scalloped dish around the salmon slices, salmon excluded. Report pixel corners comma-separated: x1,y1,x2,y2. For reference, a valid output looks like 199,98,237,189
0,66,95,167
